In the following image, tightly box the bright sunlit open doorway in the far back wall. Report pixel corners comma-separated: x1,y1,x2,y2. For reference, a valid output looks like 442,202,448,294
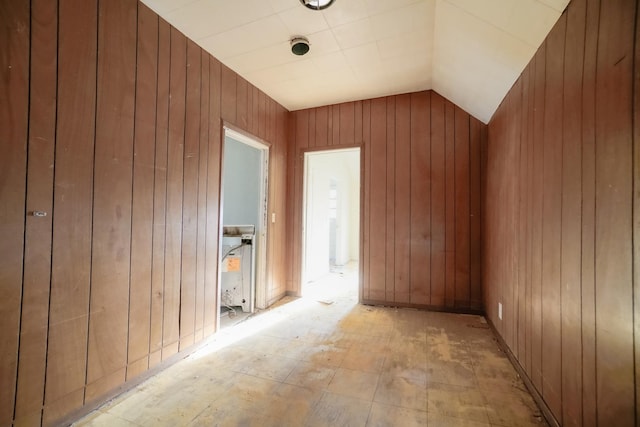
302,148,360,300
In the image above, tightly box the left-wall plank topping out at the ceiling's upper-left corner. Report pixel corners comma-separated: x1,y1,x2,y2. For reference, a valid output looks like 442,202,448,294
127,4,158,378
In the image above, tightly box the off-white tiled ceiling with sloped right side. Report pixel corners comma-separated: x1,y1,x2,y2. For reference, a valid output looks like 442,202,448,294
142,0,569,123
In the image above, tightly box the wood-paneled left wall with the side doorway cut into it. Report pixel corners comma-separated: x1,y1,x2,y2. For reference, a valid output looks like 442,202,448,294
0,0,288,425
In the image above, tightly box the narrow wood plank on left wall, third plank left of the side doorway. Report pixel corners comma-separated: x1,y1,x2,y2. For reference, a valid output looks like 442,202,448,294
180,40,201,350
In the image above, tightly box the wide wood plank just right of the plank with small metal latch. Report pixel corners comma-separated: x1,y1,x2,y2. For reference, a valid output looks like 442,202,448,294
44,1,98,421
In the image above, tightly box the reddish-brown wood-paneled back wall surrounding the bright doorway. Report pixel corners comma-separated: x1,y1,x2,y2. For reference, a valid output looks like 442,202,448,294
287,91,486,310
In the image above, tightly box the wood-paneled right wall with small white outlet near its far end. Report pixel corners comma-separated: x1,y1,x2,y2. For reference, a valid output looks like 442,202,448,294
484,0,640,426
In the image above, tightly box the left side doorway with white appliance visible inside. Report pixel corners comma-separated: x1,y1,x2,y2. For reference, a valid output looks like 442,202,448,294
218,127,269,328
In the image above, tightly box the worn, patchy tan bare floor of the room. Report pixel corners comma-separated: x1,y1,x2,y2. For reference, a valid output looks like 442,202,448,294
75,270,546,427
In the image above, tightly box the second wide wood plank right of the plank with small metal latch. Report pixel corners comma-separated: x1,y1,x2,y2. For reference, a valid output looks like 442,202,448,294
85,0,137,400
